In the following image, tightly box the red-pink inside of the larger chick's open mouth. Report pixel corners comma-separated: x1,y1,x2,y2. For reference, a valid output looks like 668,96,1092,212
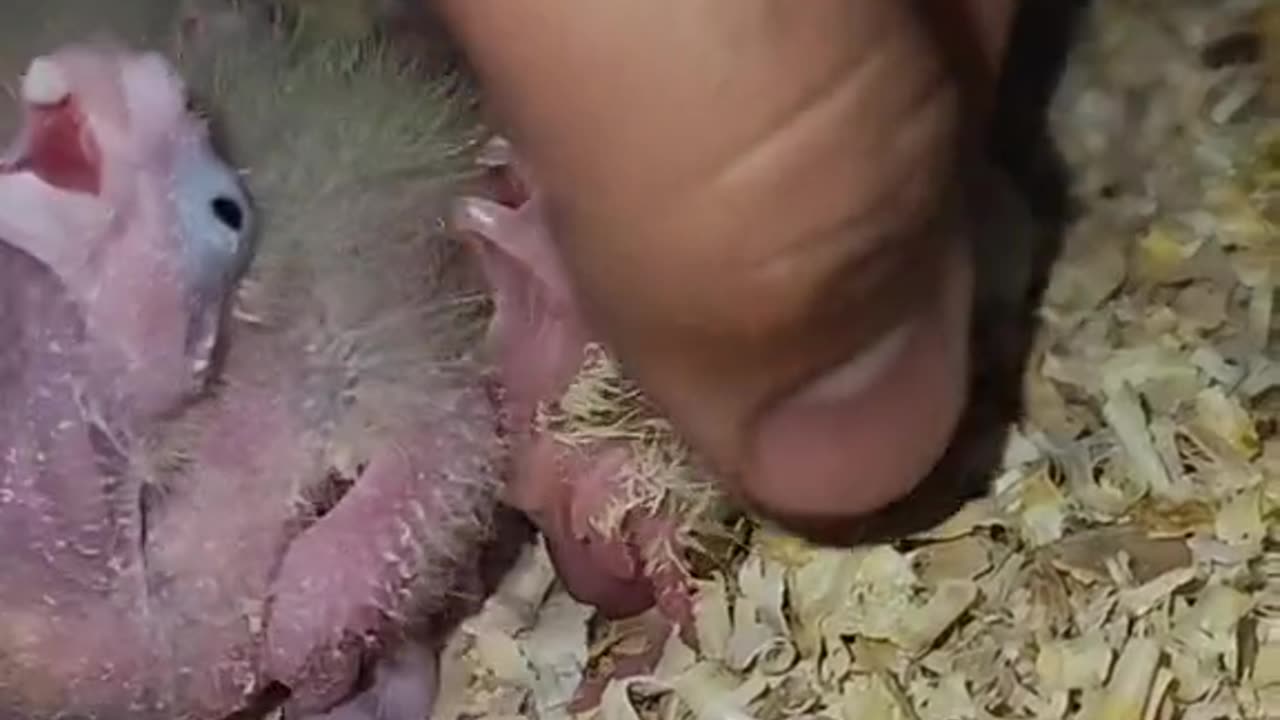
0,73,102,195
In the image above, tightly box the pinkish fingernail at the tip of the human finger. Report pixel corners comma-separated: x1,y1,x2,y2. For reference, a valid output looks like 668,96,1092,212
742,243,970,524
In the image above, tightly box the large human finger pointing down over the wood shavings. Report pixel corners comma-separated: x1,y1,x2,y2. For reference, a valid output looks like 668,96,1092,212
438,0,1015,537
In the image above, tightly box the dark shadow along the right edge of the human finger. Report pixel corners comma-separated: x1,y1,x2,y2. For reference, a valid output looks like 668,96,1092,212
819,0,1089,543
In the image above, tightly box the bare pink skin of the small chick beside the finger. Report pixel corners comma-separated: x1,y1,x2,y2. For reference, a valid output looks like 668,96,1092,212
457,142,692,629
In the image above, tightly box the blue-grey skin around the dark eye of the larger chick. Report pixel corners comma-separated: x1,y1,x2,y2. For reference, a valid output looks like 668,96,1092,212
173,138,256,377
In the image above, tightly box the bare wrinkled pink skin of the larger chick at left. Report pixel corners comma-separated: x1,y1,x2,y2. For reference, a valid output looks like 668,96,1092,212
0,43,522,720
